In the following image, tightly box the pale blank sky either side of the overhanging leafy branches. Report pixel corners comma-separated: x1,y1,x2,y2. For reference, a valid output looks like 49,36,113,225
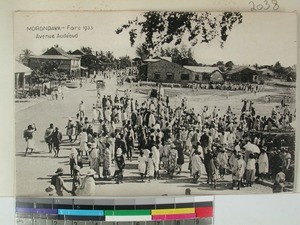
14,11,297,66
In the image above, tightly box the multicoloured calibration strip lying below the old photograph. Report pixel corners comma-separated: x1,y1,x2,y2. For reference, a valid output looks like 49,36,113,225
16,198,213,222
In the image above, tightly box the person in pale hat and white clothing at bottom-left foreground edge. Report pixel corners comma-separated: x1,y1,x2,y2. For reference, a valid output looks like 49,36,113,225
75,169,96,196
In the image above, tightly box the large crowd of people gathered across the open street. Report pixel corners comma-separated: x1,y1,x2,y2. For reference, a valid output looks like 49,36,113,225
24,73,294,195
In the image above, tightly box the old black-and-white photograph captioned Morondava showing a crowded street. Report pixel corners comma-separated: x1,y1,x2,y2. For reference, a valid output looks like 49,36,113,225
12,11,298,197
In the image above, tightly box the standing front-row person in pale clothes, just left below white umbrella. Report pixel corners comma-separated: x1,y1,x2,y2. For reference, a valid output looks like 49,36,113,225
232,152,246,190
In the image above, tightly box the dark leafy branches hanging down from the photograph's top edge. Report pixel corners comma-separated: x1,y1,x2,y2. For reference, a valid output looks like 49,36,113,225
116,11,243,50
